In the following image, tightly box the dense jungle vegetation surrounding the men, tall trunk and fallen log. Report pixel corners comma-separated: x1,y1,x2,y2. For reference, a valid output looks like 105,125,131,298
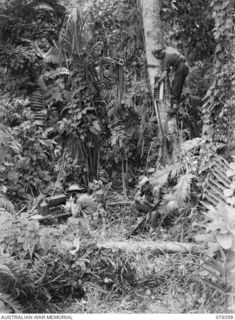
0,0,235,313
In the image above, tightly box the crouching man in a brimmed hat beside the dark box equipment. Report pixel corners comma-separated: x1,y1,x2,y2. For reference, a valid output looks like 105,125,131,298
68,184,97,219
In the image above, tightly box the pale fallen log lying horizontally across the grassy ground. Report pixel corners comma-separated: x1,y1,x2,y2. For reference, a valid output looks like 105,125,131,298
97,241,203,253
